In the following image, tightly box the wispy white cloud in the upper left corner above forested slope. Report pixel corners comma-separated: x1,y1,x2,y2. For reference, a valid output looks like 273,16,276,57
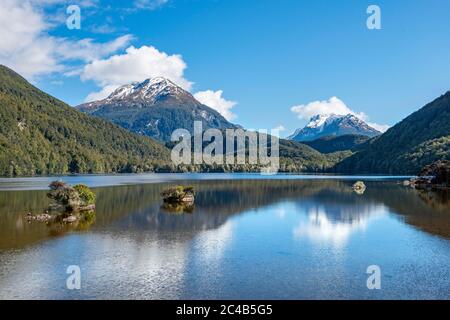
0,0,132,80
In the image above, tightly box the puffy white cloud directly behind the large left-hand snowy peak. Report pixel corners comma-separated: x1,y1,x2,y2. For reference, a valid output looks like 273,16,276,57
81,46,192,100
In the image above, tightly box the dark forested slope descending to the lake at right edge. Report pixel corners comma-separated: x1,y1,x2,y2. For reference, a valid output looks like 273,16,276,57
336,91,450,175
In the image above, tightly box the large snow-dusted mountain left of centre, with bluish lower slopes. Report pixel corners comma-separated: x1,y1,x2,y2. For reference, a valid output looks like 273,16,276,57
77,77,239,142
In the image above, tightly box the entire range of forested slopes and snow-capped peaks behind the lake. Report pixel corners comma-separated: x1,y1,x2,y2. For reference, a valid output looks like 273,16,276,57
0,66,450,176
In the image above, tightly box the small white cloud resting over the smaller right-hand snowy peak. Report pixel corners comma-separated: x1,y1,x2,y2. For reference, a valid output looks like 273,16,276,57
291,97,389,132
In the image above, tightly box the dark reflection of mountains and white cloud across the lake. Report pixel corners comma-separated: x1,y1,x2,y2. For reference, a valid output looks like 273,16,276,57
0,180,450,249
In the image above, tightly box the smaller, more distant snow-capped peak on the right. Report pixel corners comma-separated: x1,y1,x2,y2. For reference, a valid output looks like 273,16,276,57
288,114,381,141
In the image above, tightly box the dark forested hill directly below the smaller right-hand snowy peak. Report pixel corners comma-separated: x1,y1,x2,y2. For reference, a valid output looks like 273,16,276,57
302,134,370,153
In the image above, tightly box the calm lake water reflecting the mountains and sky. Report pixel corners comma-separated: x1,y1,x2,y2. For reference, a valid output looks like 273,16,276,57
0,174,450,299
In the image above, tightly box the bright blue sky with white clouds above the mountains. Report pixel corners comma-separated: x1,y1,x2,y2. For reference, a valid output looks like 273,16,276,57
0,0,450,136
